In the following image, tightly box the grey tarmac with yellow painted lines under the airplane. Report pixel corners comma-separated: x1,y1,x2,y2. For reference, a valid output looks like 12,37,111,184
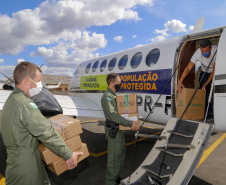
0,112,226,185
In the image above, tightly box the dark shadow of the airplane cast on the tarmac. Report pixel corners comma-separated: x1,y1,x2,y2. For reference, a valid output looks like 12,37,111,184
0,127,211,185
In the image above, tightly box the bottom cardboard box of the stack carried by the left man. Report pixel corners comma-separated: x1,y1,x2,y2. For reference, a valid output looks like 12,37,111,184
48,143,89,175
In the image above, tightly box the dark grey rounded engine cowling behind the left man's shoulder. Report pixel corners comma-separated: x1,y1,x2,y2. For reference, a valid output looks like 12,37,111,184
31,88,63,116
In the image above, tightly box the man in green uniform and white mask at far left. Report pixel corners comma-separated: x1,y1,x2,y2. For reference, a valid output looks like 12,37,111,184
1,62,82,185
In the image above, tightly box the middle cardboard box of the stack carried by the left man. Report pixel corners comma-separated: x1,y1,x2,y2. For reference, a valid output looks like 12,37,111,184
39,136,82,165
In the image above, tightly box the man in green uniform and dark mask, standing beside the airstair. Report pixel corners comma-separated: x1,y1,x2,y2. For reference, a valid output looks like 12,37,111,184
101,73,139,185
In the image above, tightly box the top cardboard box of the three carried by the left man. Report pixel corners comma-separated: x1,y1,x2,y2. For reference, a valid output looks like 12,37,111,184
49,114,82,141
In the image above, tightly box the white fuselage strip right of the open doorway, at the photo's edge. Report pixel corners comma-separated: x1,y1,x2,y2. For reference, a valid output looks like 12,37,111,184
214,29,226,131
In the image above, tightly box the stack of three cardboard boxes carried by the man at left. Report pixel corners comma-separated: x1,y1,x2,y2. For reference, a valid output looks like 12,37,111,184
39,114,89,175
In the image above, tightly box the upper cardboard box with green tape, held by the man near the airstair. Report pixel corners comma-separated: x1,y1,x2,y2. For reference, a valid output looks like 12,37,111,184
116,94,138,114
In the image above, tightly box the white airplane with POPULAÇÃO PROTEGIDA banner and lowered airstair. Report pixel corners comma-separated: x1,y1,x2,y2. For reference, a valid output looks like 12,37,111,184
0,18,226,185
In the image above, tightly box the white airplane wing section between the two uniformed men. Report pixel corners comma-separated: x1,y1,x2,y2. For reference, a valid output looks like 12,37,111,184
54,95,104,118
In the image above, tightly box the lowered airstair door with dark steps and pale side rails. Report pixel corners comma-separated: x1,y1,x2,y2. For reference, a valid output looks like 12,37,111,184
121,118,213,185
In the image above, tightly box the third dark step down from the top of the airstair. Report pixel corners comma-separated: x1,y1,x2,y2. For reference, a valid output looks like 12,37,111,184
141,164,172,179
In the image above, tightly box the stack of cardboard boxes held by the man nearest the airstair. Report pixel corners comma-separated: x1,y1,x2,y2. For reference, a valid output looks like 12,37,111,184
116,94,139,130
